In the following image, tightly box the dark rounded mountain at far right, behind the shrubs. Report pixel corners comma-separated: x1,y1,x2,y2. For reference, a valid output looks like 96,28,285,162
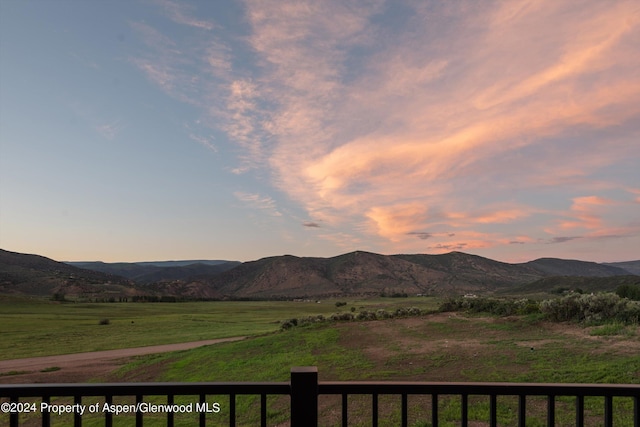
520,258,629,277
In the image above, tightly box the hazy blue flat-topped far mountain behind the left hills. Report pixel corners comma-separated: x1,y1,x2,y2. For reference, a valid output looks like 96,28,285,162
67,260,241,284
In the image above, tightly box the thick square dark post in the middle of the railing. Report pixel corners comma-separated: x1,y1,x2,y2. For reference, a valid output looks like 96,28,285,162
291,366,318,427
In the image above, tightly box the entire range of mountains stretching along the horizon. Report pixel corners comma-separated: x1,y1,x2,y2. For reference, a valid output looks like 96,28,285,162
0,251,640,299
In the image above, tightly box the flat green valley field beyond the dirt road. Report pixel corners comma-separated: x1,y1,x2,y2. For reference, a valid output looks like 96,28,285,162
0,297,438,360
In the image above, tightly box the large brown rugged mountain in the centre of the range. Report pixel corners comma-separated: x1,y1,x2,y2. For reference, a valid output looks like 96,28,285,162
168,251,543,298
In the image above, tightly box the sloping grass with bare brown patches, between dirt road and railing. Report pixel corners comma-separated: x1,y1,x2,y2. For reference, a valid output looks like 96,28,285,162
109,314,640,427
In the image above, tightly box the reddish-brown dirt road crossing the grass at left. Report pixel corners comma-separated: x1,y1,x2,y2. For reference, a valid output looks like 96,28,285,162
0,337,246,384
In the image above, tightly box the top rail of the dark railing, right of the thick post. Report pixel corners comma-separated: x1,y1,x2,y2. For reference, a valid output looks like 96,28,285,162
318,381,640,397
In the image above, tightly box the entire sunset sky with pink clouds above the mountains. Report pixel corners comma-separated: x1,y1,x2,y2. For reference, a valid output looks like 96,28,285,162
0,0,640,262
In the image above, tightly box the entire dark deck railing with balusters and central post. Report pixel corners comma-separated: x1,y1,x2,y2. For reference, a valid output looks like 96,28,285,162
0,367,640,427
